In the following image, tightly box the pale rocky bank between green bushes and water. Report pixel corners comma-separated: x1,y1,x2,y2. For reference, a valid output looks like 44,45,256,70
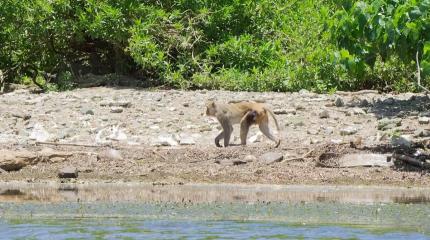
0,87,430,186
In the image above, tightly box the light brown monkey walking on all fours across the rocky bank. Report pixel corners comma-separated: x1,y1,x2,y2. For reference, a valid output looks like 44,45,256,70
206,101,281,148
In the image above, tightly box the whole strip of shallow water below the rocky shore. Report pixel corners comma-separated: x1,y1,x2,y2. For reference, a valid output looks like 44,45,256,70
0,184,430,239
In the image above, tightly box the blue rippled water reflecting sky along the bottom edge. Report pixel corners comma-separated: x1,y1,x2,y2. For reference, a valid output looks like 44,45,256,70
0,219,428,240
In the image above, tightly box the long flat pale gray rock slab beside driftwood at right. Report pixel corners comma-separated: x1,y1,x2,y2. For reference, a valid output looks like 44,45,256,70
338,153,393,168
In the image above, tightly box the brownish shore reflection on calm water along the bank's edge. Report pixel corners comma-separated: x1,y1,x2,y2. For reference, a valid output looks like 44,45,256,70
0,183,430,203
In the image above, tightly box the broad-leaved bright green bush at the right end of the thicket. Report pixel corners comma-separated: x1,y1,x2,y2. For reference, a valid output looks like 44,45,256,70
329,0,430,91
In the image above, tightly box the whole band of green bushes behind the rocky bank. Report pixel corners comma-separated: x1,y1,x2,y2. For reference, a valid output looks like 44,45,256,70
0,0,430,92
